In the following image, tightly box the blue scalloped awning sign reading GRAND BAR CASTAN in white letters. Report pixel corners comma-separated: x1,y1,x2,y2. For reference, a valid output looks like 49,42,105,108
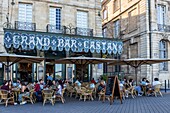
4,29,123,54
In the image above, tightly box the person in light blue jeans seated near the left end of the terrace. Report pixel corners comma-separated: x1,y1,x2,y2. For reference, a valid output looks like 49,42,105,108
18,82,29,105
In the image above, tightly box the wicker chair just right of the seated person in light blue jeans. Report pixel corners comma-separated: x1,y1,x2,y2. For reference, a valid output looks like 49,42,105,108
22,89,35,104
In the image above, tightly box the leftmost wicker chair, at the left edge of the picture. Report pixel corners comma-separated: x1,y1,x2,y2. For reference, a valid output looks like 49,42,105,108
0,90,14,107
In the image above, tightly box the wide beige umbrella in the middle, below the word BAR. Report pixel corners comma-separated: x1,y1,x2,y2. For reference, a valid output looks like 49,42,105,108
54,56,117,81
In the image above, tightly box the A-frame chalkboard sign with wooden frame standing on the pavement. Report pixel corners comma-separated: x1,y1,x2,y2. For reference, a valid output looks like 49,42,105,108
103,76,122,105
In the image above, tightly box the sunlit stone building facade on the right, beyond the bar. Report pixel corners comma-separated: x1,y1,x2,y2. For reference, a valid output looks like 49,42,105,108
101,0,170,83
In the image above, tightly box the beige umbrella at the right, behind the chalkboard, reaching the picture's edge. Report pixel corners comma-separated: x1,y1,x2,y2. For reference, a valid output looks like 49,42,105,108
108,58,170,82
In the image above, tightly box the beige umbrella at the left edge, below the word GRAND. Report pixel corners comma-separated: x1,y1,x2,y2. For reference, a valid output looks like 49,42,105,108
0,53,44,79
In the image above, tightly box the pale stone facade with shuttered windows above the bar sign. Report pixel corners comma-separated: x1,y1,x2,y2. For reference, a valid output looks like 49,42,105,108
0,0,103,83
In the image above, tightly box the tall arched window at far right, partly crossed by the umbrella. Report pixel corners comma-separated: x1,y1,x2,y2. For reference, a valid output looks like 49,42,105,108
159,40,168,71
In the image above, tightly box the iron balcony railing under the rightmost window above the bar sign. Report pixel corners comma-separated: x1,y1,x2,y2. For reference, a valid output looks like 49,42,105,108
75,27,93,36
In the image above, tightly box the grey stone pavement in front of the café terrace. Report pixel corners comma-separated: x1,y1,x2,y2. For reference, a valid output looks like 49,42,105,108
0,94,170,113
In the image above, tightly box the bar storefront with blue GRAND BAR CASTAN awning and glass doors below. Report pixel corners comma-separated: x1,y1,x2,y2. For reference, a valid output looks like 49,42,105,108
1,29,123,82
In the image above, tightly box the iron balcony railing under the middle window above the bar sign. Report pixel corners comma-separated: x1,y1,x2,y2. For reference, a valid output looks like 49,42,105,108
46,24,63,33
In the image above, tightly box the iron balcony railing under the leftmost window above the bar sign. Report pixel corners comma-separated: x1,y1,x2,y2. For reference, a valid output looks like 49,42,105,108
15,21,36,31
